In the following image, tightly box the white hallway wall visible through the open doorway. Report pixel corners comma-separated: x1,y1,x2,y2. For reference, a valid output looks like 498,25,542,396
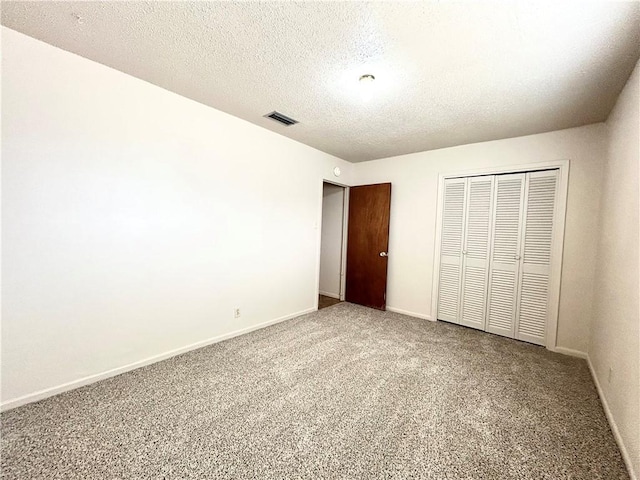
320,183,344,298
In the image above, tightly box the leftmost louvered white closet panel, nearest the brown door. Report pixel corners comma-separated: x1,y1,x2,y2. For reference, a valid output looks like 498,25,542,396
438,178,466,323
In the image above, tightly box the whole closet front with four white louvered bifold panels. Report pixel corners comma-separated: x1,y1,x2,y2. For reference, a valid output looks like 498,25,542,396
432,161,569,350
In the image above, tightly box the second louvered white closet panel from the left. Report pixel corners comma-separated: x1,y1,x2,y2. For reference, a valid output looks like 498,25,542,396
460,176,495,330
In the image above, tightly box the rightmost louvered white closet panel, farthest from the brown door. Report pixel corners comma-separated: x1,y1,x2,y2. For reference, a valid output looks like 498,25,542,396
515,170,557,345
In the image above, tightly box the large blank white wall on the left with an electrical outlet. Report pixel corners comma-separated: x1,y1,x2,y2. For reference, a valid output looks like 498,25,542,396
2,28,352,406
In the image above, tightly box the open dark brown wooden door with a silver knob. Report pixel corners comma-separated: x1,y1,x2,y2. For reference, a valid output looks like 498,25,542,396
345,183,391,310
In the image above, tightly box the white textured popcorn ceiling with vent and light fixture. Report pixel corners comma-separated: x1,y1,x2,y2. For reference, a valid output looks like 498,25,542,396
2,1,640,162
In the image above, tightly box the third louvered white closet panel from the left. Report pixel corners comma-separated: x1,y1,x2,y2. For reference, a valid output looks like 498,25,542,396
486,173,525,338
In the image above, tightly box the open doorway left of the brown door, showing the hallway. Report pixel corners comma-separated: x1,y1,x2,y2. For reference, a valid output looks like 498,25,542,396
318,182,348,309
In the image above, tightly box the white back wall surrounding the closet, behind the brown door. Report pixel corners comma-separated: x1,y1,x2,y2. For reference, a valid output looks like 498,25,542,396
355,124,605,353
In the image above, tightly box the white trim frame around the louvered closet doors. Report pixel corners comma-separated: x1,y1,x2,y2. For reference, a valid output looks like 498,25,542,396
431,160,570,352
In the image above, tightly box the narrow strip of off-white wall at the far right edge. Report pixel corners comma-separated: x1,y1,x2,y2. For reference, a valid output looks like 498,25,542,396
589,64,640,478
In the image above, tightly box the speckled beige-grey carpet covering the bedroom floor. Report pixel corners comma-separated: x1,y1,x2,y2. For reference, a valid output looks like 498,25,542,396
1,303,628,480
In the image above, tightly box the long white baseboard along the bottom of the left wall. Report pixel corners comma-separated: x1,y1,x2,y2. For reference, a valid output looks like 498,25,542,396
0,308,317,412
